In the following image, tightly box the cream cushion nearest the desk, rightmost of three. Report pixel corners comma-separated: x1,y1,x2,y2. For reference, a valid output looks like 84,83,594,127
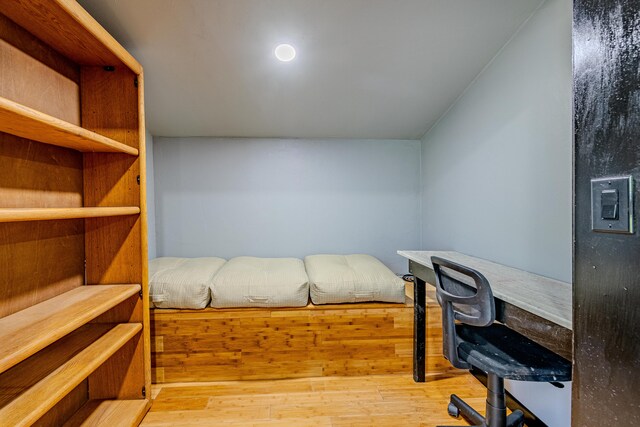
304,255,405,304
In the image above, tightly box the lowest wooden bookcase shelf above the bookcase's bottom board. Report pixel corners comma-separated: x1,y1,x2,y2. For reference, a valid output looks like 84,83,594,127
0,323,142,427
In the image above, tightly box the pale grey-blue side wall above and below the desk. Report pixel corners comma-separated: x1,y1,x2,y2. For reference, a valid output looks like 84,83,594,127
422,0,572,427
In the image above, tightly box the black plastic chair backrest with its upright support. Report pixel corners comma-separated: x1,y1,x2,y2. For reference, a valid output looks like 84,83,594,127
431,256,496,369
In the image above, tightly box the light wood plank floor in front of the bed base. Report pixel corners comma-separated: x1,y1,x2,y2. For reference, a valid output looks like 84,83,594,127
142,374,486,427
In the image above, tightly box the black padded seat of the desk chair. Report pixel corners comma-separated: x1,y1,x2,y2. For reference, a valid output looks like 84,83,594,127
456,323,571,381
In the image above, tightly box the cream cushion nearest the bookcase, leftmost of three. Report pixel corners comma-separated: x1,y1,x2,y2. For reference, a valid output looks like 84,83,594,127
149,257,226,308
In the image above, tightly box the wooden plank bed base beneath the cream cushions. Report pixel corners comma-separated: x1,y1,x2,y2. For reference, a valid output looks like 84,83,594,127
151,288,455,383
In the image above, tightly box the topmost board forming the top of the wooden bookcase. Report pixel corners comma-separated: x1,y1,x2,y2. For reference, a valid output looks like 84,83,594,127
0,0,142,74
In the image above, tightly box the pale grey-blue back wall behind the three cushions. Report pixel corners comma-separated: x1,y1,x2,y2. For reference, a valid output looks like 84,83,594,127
154,137,420,273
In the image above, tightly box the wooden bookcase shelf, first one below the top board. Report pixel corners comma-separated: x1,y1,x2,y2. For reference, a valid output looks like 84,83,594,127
0,97,138,156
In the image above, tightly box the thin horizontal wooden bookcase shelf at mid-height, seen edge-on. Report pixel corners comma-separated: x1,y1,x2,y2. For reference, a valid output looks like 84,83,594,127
0,206,140,222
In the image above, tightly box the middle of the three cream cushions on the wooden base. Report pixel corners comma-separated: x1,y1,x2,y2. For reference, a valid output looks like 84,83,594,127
211,257,309,308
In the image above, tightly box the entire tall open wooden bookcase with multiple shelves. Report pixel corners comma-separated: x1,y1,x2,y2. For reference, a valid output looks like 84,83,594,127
0,0,151,427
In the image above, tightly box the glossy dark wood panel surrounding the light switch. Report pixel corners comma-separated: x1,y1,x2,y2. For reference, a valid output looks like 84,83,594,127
572,0,640,426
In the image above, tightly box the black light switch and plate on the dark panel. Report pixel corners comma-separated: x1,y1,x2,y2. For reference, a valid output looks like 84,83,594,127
591,176,634,234
